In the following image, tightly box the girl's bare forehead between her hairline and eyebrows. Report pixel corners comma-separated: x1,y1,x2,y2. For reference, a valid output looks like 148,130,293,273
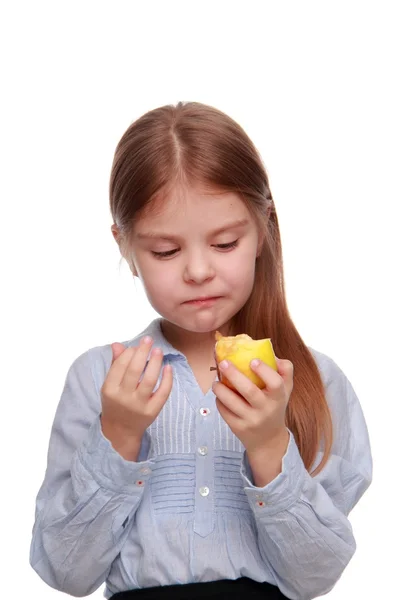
134,185,250,232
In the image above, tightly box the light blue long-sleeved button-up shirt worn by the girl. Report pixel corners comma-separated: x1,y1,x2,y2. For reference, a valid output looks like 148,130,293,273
30,319,372,600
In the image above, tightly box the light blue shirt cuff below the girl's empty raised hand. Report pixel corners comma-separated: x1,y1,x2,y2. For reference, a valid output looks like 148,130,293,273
77,416,155,495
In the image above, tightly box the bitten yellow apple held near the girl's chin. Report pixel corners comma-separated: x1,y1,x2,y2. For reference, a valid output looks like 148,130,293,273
215,331,278,390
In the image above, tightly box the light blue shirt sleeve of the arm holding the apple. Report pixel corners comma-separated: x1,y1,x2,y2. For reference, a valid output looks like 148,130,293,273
241,360,372,600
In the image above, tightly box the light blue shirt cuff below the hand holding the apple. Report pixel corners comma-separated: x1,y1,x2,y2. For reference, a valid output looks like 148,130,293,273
240,429,307,517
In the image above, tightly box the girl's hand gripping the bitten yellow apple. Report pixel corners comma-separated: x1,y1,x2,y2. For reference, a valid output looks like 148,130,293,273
212,358,294,452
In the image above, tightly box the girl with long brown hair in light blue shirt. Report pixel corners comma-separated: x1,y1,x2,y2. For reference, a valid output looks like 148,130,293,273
30,103,372,600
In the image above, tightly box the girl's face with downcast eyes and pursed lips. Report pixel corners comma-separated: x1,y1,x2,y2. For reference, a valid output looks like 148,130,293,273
128,187,260,333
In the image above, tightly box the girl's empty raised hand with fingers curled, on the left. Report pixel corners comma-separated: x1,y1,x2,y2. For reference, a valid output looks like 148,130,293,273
101,337,172,460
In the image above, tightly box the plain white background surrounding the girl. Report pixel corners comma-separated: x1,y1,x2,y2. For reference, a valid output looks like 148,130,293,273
0,0,400,600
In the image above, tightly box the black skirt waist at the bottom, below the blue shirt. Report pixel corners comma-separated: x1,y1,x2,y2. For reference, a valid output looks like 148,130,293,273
110,577,288,600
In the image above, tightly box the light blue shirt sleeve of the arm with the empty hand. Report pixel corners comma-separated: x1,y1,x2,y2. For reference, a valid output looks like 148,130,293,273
30,349,152,597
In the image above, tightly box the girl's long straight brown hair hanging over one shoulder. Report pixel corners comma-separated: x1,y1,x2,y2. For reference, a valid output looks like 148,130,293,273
110,102,332,475
